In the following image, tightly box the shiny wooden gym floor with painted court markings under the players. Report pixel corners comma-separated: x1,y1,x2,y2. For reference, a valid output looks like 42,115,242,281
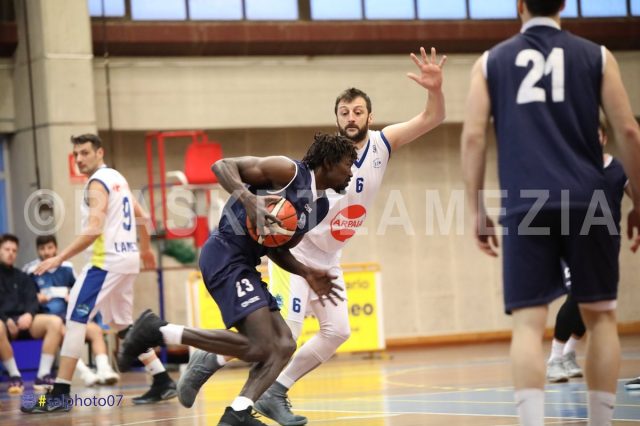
0,336,640,426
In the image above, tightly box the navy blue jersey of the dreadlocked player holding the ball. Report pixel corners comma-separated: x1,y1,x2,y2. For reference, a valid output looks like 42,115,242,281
208,160,329,272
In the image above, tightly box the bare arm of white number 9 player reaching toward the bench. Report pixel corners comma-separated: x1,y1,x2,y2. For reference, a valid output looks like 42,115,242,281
33,180,109,275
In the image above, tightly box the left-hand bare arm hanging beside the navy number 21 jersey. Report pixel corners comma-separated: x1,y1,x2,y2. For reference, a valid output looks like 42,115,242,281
462,58,498,256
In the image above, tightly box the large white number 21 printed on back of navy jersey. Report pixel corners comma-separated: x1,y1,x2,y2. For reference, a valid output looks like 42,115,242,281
516,47,564,104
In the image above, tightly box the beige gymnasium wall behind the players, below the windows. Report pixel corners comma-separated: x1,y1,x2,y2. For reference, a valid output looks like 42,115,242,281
0,52,640,338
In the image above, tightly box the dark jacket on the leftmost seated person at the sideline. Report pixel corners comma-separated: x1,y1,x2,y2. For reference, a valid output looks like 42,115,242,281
0,263,39,321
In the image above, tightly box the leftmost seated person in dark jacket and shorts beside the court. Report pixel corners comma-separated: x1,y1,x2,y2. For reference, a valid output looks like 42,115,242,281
0,234,62,394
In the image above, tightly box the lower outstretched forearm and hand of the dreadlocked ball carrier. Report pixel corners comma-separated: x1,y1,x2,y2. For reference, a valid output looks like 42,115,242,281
267,247,344,306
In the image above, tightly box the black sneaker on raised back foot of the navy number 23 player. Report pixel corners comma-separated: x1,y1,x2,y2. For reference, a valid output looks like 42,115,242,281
118,309,168,372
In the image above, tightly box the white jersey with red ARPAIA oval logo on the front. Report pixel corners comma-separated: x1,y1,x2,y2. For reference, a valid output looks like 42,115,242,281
291,130,391,266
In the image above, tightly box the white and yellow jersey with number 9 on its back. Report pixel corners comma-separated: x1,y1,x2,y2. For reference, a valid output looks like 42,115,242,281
80,166,140,274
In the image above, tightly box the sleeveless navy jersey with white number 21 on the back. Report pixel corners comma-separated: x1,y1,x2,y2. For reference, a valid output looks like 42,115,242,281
484,18,606,220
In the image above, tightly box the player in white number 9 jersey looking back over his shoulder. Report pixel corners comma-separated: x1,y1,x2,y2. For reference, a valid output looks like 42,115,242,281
21,134,176,413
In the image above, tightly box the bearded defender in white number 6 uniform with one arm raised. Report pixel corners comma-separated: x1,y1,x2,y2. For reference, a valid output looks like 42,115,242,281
178,48,446,425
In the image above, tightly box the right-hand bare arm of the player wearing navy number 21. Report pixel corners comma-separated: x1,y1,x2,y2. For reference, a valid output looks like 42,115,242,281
601,50,640,252
